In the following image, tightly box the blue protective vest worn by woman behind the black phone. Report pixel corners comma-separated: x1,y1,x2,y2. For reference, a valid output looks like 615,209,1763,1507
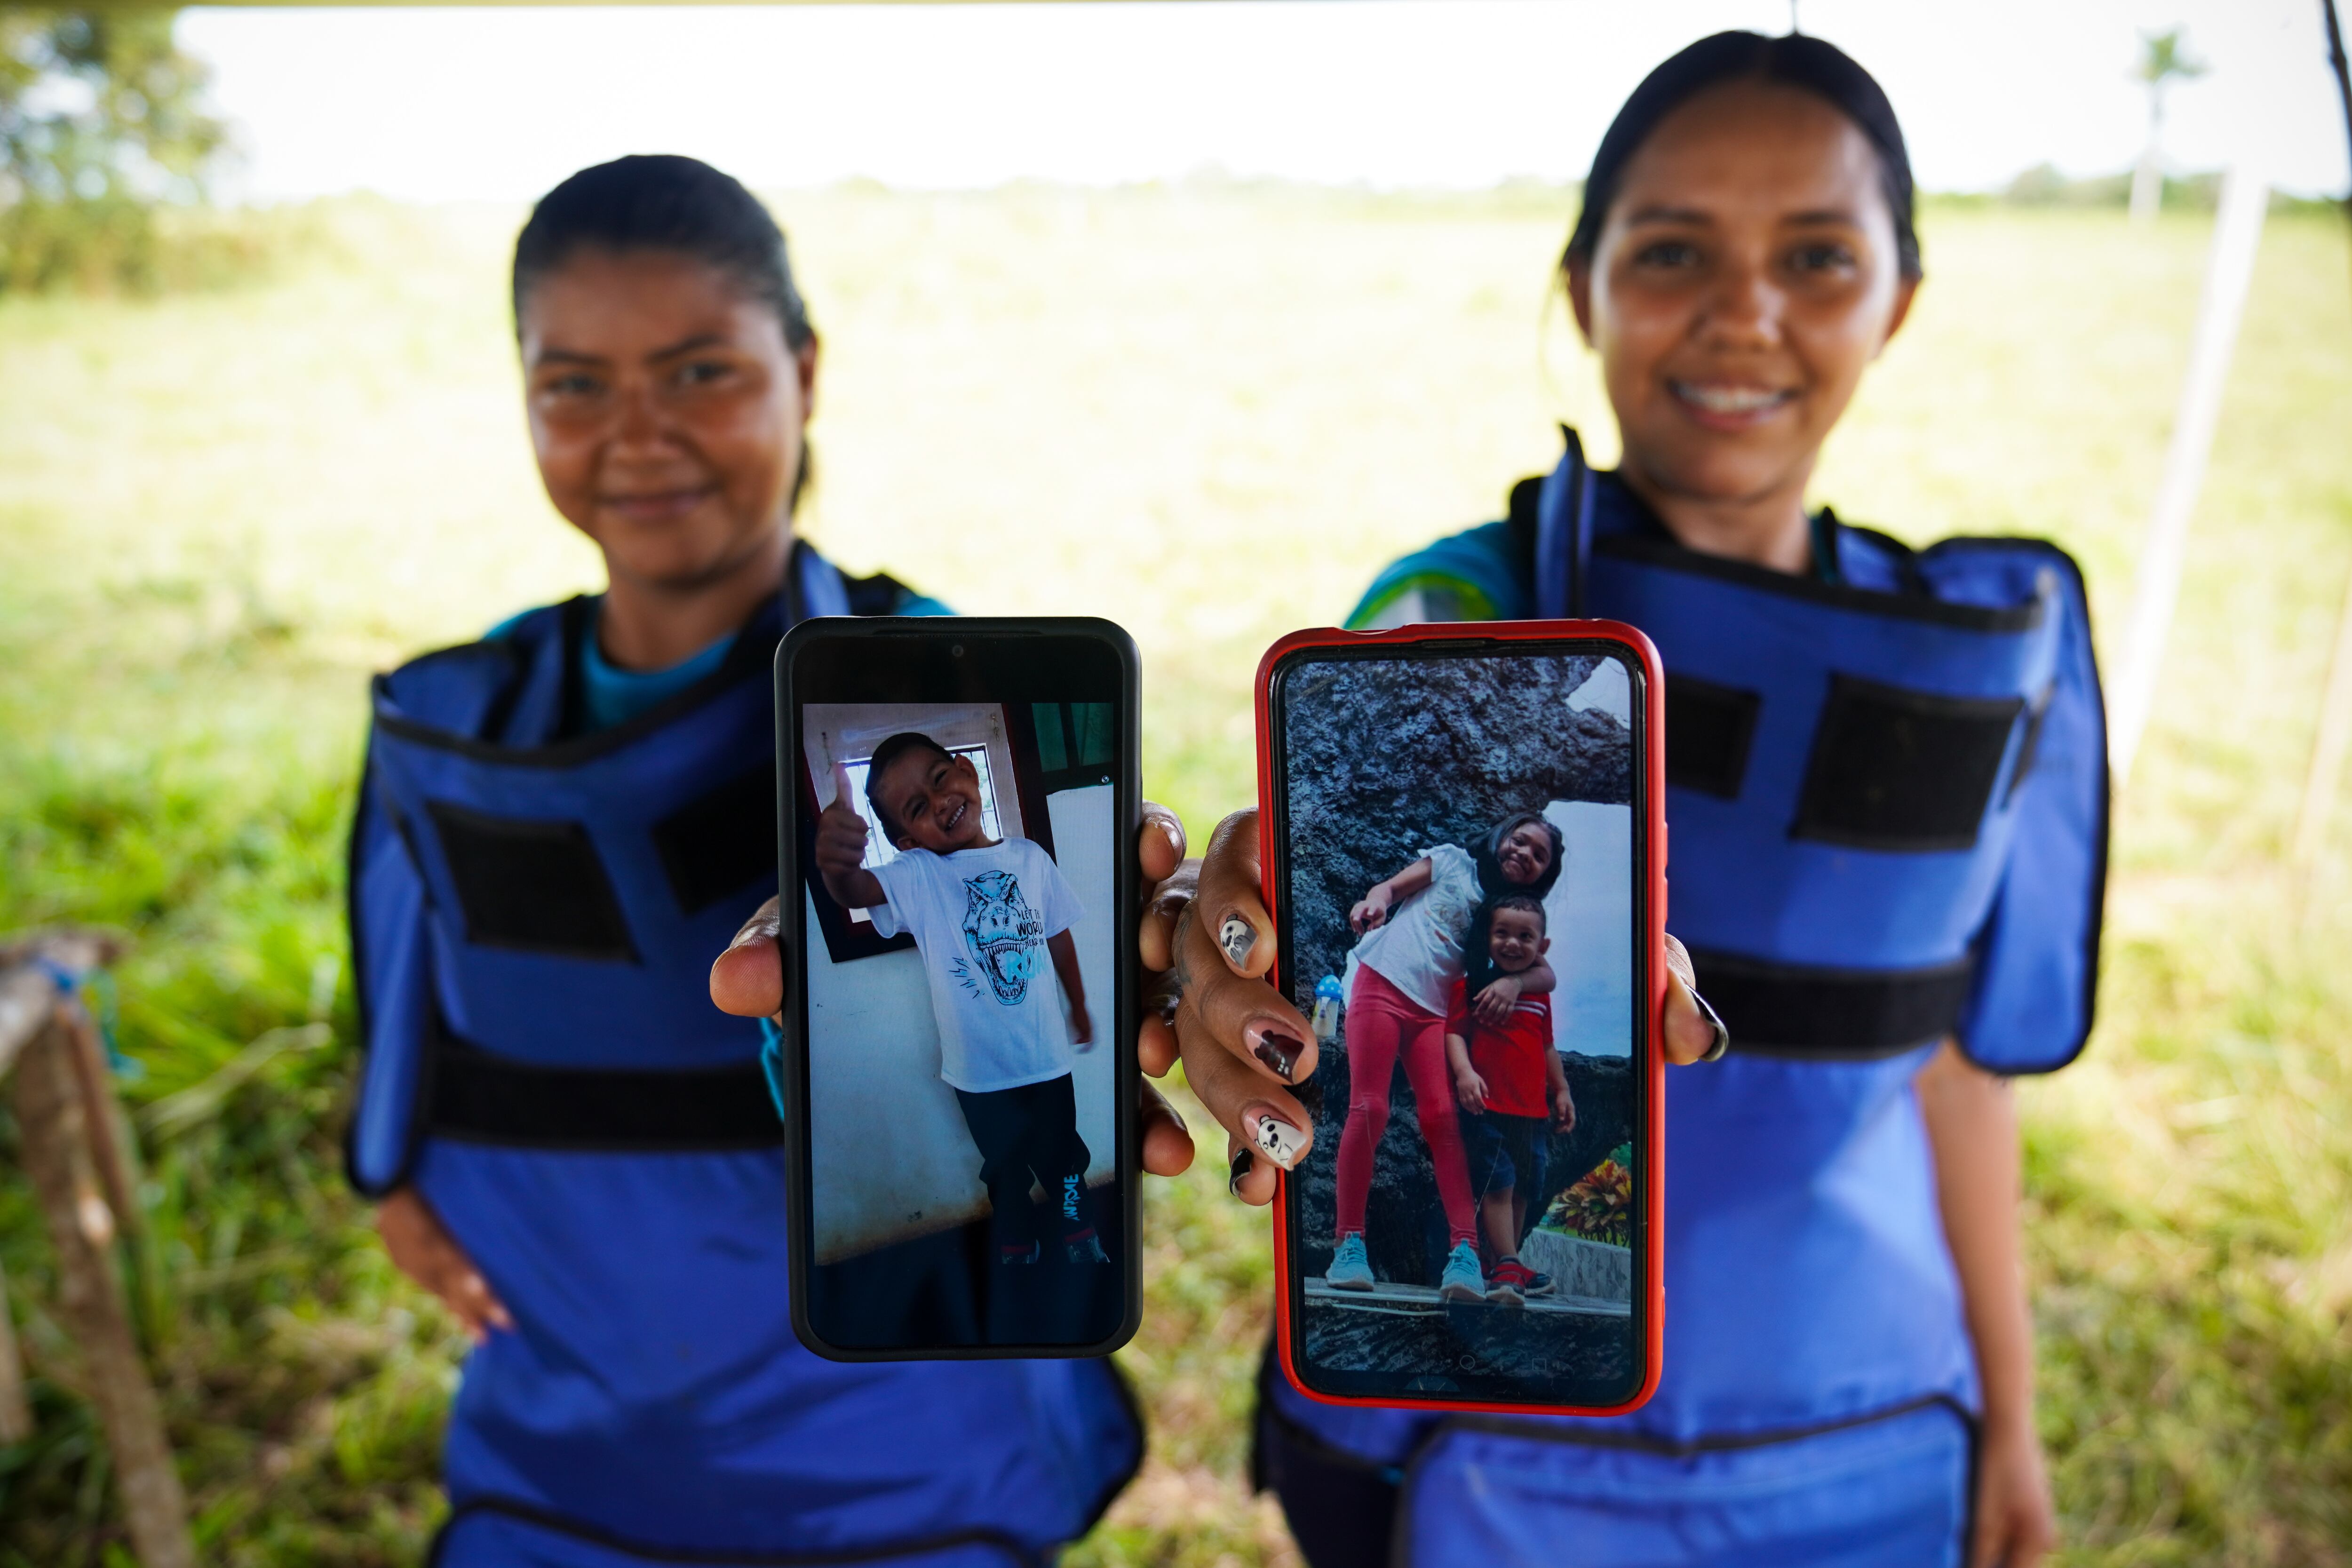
348,545,1143,1568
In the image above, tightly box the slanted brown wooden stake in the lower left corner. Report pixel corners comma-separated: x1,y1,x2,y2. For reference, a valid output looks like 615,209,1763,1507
16,1020,195,1568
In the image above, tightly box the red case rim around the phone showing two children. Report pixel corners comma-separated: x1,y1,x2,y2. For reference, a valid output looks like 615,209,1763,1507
1256,621,1668,1415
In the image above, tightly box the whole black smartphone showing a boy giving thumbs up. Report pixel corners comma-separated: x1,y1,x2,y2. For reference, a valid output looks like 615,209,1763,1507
779,621,1138,1359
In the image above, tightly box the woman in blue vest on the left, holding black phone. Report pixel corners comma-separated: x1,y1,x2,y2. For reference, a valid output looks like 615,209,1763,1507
348,158,1188,1568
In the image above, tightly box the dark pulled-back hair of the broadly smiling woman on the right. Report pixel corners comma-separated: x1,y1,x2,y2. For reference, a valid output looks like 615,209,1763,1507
1562,33,1922,278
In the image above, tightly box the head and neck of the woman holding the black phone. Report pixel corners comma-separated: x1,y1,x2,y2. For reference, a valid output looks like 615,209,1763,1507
515,158,816,670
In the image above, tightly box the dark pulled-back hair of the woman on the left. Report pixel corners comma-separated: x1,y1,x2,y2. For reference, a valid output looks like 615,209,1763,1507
513,153,816,505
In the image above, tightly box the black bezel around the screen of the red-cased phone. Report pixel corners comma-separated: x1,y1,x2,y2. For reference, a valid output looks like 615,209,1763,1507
1265,628,1663,1413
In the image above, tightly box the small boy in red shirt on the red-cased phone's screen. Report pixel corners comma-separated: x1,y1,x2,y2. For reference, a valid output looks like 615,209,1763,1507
1446,893,1576,1307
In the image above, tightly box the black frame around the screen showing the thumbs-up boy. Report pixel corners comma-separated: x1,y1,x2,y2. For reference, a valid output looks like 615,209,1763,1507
774,616,1143,1361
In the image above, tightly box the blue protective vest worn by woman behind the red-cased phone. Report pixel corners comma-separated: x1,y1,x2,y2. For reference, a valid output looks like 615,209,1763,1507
1268,435,2107,1568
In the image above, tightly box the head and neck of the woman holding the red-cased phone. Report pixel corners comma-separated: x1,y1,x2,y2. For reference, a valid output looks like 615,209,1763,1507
1562,49,1922,571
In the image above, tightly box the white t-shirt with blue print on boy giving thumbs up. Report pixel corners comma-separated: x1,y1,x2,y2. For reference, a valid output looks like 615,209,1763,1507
870,837,1084,1093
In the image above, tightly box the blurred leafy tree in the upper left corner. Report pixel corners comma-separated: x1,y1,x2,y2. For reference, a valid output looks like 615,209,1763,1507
0,7,226,292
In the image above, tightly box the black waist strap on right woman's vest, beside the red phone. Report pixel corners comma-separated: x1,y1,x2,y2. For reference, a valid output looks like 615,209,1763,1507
1691,947,1973,1060
